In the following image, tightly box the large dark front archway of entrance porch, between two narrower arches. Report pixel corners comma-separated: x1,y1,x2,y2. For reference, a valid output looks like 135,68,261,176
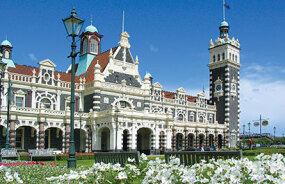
137,127,153,155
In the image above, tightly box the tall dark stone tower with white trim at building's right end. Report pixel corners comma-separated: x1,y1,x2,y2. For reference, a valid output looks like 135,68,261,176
208,20,241,147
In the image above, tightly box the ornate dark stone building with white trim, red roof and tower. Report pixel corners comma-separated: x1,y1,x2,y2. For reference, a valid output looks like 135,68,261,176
0,17,240,154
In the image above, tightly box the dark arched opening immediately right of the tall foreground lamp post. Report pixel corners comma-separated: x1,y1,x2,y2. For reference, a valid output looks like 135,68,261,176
74,128,87,153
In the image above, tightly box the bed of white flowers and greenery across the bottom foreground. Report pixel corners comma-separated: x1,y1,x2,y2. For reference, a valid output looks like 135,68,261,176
0,154,285,184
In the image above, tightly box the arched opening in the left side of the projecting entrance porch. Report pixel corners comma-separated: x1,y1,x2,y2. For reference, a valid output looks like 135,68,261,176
97,126,111,151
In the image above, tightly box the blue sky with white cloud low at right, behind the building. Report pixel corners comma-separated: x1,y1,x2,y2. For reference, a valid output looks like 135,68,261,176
0,0,285,135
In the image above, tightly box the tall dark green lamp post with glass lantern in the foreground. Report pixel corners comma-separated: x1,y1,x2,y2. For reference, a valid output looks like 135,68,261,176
62,8,84,168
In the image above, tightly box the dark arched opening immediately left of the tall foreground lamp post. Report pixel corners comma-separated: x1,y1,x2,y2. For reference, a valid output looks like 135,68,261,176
45,127,64,150
